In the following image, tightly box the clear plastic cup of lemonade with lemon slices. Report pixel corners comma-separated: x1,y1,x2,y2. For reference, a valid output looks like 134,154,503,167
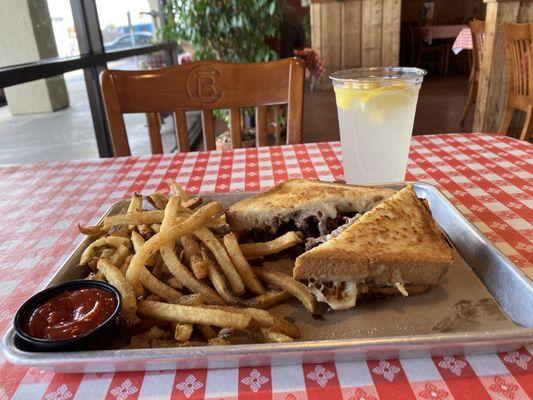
332,68,425,183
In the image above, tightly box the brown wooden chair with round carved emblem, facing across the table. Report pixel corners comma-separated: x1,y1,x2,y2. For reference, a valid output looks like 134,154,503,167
100,58,304,157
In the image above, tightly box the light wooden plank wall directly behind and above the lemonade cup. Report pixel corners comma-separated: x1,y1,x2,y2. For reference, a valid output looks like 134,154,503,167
311,0,401,82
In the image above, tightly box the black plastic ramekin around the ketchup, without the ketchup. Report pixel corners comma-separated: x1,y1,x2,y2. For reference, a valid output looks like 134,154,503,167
13,279,122,351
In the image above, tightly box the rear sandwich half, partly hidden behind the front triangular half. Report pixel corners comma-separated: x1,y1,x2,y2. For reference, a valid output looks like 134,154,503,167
226,179,396,248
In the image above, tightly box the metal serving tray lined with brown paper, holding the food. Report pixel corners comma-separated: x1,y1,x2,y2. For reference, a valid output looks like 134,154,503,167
2,182,533,372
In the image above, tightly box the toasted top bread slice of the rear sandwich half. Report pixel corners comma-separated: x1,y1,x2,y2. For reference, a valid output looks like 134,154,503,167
226,179,396,235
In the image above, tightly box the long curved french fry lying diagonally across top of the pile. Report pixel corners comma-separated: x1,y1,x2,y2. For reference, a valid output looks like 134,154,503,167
126,202,222,290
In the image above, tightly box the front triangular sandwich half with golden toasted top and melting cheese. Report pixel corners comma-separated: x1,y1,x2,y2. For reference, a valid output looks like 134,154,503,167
293,186,453,310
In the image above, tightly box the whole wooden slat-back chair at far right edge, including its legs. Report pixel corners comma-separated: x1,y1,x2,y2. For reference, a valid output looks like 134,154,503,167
498,23,533,140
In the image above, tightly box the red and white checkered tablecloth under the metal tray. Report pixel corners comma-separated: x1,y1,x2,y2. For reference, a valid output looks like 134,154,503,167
0,134,533,400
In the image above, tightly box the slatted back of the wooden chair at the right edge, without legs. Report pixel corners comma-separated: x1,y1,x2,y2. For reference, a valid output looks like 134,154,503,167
504,23,533,111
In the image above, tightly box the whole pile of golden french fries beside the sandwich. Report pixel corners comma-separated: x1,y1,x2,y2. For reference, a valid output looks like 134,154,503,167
78,181,316,348
